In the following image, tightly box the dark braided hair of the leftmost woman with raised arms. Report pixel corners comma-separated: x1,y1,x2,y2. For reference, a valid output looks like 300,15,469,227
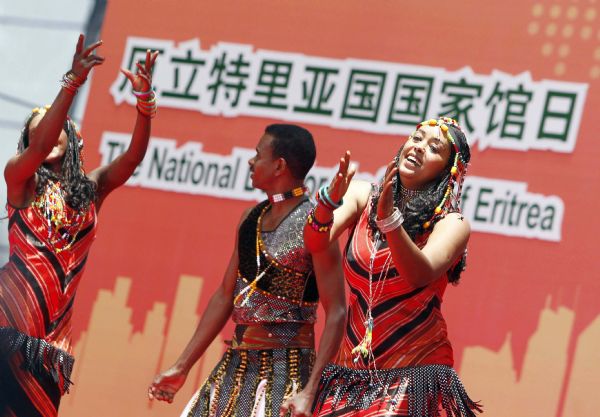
17,109,96,212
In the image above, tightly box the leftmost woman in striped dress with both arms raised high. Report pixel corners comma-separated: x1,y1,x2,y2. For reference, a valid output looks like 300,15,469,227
0,35,158,417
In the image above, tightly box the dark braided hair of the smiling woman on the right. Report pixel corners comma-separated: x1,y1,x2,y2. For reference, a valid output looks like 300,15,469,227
368,125,471,284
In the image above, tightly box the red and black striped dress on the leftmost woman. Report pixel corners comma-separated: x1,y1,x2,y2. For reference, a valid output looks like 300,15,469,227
0,184,96,417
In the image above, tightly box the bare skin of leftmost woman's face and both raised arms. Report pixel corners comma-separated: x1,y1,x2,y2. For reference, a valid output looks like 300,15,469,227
4,35,158,209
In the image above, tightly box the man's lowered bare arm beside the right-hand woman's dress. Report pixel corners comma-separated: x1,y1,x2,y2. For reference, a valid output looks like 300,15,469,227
281,242,346,417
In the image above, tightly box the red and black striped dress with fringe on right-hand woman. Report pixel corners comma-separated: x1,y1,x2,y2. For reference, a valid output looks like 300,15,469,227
314,208,479,417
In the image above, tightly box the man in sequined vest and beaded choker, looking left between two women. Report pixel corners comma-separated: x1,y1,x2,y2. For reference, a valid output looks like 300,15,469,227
148,124,346,417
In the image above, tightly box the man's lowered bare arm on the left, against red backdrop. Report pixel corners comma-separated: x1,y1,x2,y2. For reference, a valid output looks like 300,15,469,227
148,210,249,402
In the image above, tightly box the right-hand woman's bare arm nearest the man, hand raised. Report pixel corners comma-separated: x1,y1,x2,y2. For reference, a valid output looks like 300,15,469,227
304,151,371,254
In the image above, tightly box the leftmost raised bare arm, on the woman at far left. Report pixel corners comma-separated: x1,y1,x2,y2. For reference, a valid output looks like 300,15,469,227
4,35,104,207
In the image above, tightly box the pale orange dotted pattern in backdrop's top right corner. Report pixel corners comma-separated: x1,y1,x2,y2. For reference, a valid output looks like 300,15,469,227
527,0,600,80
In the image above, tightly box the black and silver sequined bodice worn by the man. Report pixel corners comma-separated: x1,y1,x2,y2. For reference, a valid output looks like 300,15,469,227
233,200,318,324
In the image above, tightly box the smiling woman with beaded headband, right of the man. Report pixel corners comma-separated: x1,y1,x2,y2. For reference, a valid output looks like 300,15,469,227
304,117,481,417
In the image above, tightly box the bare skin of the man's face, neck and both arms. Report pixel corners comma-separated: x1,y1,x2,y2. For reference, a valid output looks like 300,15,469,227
148,134,346,417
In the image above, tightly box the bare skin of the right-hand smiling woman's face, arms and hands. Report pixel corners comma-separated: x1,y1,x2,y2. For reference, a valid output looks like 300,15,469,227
304,126,471,288
